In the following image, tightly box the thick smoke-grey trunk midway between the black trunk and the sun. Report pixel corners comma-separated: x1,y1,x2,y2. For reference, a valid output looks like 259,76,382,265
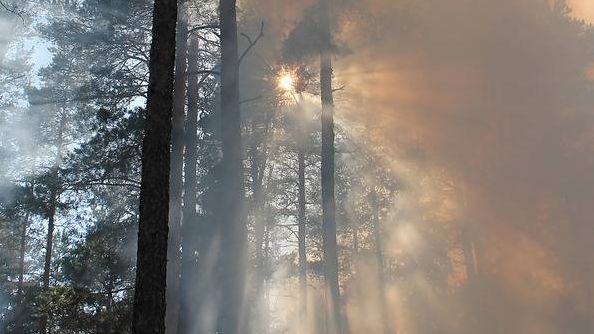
218,0,248,334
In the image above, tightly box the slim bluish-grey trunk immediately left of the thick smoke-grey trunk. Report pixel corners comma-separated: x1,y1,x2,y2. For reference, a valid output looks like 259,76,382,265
178,37,203,334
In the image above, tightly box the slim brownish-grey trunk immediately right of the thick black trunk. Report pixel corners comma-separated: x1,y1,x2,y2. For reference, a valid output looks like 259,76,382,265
165,0,188,334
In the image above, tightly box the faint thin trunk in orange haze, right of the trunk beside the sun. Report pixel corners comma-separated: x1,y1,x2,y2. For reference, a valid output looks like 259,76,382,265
371,188,392,334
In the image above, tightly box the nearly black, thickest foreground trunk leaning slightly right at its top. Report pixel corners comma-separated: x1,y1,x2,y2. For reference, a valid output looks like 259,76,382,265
132,0,177,334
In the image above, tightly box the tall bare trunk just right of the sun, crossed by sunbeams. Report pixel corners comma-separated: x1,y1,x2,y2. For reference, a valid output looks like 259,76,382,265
320,0,342,333
